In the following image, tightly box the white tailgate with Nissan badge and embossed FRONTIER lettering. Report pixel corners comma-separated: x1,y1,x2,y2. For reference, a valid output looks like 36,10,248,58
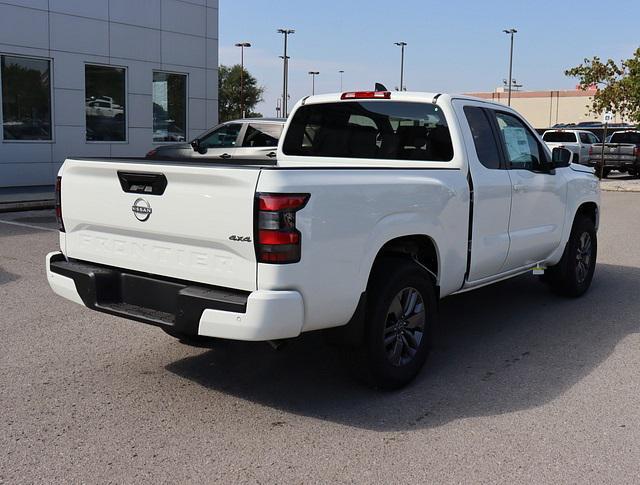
62,160,260,291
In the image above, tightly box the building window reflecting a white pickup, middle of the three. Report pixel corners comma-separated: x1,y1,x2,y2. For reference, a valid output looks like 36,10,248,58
84,65,127,141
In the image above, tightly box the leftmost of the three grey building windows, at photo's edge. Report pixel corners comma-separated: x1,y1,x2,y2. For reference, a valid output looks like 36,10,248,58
0,56,51,141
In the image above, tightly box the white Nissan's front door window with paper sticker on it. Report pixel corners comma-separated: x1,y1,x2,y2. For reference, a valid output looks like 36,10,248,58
496,112,544,170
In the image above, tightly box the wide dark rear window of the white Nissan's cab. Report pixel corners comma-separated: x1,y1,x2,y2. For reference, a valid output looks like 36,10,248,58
282,101,453,161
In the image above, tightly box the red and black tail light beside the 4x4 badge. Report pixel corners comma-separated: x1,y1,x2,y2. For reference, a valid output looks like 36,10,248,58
254,194,309,264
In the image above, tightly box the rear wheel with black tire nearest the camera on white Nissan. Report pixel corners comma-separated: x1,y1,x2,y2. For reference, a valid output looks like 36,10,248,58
357,258,437,389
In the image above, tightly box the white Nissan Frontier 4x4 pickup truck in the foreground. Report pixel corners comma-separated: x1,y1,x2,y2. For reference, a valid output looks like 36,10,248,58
46,92,599,388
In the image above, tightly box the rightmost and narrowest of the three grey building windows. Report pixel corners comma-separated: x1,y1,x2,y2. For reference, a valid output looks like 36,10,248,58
153,72,187,142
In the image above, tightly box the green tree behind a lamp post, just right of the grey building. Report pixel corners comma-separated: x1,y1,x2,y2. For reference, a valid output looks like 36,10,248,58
218,64,264,122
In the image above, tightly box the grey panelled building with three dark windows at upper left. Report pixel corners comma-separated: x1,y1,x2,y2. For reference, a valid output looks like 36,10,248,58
0,0,218,199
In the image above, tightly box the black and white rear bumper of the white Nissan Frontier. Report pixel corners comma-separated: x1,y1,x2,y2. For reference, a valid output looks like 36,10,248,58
46,252,304,341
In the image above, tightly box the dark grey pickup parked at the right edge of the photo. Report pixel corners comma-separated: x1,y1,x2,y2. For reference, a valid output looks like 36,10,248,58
588,130,640,178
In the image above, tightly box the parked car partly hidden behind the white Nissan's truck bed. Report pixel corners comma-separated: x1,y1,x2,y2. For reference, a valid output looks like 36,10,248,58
147,118,286,160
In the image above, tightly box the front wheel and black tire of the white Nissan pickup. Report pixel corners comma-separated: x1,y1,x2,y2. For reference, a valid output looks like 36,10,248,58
544,214,598,298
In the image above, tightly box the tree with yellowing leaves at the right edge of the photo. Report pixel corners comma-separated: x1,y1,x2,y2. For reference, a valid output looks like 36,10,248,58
565,48,640,124
